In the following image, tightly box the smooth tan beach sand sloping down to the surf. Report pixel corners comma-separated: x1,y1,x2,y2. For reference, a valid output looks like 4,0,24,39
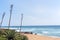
24,34,60,40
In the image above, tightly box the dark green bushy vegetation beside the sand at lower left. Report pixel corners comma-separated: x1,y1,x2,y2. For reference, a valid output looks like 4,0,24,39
0,29,28,40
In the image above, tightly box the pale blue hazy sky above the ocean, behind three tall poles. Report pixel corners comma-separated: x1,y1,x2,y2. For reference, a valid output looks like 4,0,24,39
0,0,60,26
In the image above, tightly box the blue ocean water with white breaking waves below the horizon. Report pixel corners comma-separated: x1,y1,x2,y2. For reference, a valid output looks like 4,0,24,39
2,25,60,37
